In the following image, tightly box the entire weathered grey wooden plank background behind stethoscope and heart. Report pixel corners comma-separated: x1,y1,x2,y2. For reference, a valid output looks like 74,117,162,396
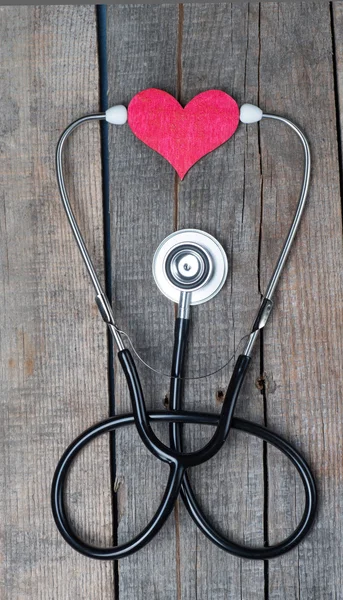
0,2,343,600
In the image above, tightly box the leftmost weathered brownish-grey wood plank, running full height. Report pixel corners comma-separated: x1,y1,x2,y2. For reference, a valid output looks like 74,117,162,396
0,6,113,600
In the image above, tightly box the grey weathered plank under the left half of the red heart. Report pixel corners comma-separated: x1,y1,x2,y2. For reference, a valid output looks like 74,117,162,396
108,5,178,600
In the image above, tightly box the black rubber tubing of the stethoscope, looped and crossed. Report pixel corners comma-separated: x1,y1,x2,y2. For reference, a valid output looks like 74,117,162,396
51,332,317,560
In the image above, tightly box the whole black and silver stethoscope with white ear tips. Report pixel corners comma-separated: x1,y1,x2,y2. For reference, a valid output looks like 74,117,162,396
51,96,317,560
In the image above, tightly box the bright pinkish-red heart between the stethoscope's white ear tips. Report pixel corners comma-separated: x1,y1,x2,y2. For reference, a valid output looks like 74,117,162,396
128,88,239,179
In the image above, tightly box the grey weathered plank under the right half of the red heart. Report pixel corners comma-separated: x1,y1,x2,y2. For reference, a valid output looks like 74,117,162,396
176,3,264,600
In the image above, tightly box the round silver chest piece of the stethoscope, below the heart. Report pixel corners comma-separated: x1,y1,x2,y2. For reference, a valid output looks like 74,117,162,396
152,229,228,305
